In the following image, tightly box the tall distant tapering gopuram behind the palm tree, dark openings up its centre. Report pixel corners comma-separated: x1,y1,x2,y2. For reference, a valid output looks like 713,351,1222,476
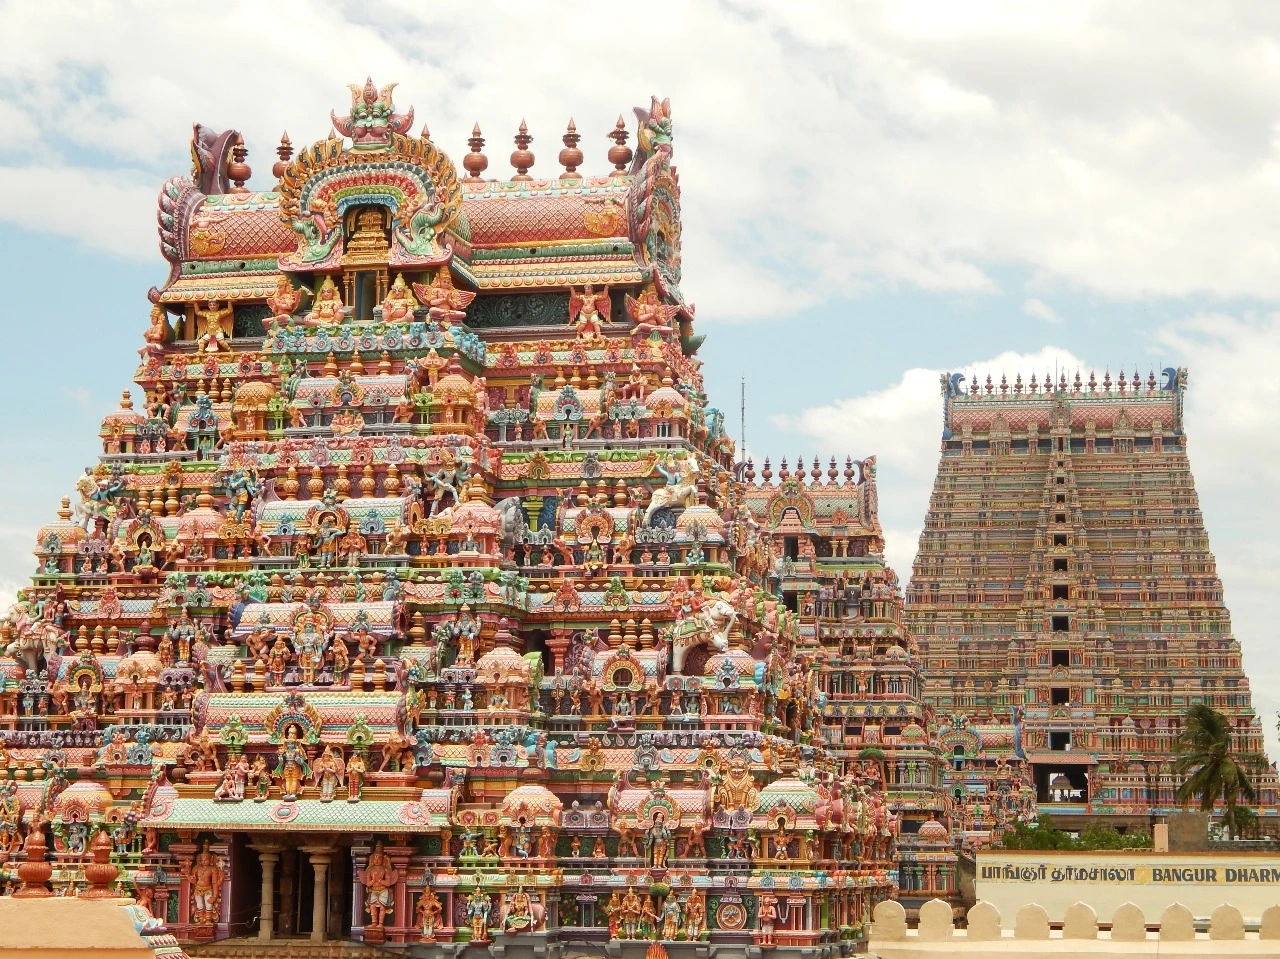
906,369,1277,842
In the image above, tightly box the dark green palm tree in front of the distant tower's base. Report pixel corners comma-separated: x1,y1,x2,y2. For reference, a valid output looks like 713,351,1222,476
1175,703,1266,839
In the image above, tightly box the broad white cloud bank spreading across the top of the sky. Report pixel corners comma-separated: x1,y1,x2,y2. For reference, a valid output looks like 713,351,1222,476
0,0,1280,319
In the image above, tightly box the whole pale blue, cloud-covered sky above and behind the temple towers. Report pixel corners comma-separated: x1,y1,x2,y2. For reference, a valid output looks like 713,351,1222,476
0,0,1280,758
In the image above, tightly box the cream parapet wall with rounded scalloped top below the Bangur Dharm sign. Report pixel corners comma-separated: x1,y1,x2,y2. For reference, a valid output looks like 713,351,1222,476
869,896,1280,959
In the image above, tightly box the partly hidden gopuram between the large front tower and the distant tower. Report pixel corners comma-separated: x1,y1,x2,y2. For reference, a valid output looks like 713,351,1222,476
744,457,957,908
